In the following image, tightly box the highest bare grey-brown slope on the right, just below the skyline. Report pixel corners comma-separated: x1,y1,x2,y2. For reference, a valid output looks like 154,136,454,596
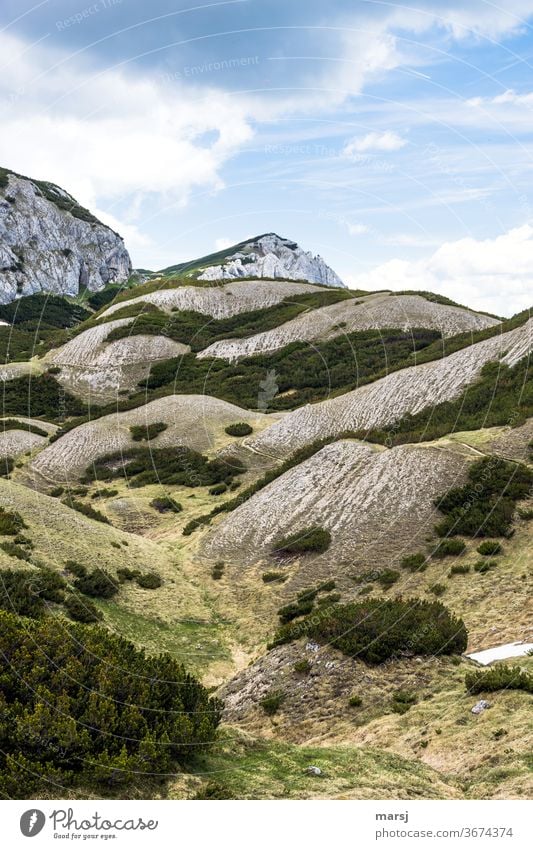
199,292,499,361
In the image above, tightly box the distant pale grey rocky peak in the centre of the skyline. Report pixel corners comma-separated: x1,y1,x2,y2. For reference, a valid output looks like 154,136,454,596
198,233,346,288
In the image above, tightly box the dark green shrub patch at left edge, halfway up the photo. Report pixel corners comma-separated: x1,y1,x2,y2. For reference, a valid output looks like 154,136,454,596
0,374,87,421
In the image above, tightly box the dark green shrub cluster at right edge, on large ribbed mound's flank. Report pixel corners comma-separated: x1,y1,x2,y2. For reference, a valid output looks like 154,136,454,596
435,457,533,537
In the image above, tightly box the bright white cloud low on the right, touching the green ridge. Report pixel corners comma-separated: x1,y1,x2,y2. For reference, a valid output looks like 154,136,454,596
350,224,533,316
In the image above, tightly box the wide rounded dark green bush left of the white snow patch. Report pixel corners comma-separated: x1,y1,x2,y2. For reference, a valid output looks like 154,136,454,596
273,598,467,663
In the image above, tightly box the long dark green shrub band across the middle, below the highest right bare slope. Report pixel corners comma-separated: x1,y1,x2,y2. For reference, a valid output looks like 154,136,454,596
141,328,439,411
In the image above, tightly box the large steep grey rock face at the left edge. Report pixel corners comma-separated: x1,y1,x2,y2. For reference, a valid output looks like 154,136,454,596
0,174,131,303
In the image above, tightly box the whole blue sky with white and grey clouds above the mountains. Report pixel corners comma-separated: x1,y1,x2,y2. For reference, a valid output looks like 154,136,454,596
0,0,533,316
